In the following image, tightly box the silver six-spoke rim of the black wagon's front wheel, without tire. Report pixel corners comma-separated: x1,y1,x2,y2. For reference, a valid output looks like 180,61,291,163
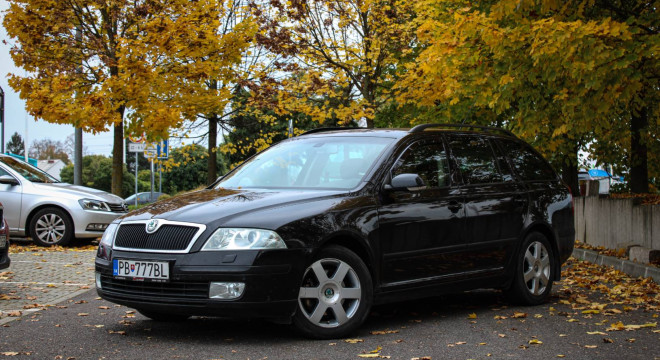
298,259,362,328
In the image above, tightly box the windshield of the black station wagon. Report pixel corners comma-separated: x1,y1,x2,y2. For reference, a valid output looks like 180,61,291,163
216,136,394,190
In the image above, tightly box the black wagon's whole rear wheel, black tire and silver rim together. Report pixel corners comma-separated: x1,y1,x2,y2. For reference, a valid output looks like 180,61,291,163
504,232,556,305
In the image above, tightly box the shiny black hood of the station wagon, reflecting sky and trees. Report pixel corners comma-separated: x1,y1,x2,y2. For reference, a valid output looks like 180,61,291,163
121,188,346,224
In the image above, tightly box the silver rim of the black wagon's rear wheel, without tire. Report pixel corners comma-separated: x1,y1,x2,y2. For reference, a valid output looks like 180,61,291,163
523,241,550,295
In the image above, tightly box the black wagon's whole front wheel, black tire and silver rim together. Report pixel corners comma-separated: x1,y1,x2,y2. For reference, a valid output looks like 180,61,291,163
293,245,373,339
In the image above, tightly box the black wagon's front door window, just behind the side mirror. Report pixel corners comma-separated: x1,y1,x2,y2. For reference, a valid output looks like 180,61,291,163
392,142,449,188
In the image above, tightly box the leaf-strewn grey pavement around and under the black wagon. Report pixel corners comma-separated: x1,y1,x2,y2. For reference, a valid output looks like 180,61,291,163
0,245,660,360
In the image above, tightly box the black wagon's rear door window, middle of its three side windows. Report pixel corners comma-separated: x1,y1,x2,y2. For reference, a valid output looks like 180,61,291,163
448,135,504,184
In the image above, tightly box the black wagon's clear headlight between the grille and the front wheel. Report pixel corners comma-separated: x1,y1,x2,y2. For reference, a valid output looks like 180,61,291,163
202,228,286,251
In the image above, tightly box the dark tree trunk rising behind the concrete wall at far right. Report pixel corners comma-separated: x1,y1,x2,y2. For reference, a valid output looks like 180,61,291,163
630,107,649,194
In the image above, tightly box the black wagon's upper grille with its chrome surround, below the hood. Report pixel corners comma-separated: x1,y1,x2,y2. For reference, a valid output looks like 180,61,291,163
112,219,206,254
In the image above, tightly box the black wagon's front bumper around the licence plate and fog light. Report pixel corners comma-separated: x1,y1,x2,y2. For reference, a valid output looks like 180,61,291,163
96,249,304,318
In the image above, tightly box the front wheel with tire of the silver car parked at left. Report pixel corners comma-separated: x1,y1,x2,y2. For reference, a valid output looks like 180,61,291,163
30,207,74,246
